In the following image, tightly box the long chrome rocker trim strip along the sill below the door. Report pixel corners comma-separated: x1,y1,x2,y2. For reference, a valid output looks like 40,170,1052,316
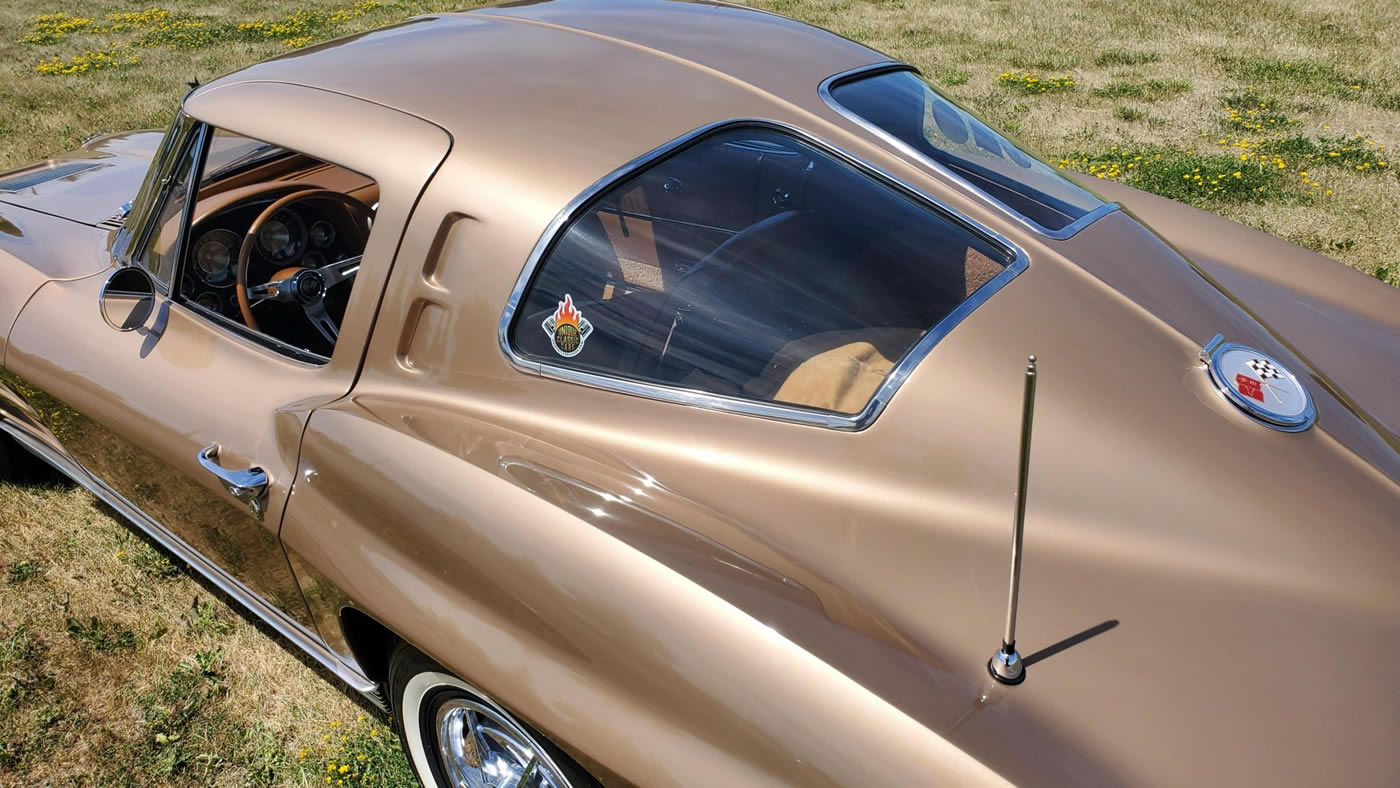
0,413,384,705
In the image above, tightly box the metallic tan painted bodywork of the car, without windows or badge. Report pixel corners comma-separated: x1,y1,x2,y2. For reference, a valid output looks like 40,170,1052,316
0,1,1400,785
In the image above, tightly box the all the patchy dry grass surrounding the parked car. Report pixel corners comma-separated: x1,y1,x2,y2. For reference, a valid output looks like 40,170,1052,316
0,0,1400,785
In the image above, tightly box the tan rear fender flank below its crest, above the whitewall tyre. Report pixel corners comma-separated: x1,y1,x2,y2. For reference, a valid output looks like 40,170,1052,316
283,399,1000,785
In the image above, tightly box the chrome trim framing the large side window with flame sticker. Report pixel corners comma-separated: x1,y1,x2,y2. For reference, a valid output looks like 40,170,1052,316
496,118,1030,431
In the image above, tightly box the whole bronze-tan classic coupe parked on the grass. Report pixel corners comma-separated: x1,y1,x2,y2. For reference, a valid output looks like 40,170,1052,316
0,0,1400,788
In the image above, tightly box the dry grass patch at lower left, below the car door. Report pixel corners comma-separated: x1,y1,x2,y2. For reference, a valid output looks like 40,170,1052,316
0,474,412,785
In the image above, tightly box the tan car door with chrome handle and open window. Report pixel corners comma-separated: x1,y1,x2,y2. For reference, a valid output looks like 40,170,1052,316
7,84,448,643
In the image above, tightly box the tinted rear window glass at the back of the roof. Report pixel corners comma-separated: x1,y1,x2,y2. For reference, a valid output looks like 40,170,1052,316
832,71,1103,230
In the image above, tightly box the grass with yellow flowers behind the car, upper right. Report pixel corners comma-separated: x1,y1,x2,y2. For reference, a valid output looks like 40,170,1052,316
749,0,1400,284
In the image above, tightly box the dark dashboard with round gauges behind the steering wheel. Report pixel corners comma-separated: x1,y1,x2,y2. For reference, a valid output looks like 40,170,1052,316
181,199,364,323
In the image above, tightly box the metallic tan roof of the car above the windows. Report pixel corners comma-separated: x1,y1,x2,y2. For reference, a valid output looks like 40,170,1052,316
186,0,888,172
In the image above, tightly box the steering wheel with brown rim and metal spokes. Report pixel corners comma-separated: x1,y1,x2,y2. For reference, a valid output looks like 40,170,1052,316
234,189,374,346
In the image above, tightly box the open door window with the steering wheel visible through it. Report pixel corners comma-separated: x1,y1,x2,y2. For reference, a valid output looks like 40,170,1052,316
161,129,379,363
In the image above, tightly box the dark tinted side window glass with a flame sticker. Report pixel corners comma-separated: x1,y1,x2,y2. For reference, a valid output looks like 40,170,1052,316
508,127,1012,414
